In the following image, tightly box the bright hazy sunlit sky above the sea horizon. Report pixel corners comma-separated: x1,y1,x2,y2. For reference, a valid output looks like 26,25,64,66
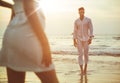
0,0,120,34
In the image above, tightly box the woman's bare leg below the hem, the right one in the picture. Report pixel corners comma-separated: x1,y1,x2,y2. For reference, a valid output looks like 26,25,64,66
35,70,59,83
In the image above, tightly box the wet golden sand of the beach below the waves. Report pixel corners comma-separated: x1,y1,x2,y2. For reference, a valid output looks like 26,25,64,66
0,54,120,83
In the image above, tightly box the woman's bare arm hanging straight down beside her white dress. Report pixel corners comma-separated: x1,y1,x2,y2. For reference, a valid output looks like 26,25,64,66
23,0,52,66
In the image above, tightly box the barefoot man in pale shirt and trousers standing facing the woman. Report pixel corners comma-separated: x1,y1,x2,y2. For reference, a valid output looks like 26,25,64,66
73,7,94,75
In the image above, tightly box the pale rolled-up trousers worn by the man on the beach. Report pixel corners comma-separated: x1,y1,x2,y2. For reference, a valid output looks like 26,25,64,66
78,41,89,65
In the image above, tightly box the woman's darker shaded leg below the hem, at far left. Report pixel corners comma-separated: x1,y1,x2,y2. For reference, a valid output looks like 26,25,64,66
7,68,25,83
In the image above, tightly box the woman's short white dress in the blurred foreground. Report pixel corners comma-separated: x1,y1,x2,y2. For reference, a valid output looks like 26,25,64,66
0,0,54,72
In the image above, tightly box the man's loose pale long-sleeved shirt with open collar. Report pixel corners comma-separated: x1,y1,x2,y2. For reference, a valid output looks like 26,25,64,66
73,17,93,41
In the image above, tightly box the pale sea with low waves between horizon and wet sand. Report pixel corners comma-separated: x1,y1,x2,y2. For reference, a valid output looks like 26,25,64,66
0,29,120,56
